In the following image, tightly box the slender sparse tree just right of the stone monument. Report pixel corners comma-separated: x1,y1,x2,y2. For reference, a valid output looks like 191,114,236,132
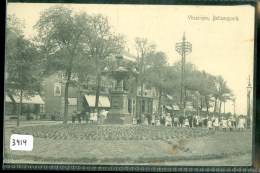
135,37,156,114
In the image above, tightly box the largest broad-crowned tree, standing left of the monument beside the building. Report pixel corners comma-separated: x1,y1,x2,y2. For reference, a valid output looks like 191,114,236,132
34,6,90,124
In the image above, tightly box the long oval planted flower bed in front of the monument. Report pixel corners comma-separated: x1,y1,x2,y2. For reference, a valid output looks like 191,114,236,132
12,124,214,140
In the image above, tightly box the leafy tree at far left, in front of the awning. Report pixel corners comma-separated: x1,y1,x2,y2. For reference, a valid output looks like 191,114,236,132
6,16,43,126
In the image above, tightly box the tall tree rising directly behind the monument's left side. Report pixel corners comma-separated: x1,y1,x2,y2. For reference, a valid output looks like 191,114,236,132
84,14,125,110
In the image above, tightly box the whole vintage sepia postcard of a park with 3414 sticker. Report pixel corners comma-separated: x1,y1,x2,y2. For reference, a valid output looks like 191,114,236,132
3,3,255,171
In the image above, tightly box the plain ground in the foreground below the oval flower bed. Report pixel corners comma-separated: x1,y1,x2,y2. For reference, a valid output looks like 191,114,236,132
4,127,252,166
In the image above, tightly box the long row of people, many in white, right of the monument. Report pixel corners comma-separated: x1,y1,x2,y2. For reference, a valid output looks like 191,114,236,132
137,113,246,131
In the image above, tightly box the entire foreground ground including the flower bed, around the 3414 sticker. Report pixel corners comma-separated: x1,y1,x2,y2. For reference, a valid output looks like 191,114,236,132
4,125,252,166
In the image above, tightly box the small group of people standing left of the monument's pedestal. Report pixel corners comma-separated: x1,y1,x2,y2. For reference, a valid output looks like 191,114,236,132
72,109,108,124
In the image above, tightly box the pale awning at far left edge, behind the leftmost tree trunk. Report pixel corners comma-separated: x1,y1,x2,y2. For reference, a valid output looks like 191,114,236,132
5,94,45,105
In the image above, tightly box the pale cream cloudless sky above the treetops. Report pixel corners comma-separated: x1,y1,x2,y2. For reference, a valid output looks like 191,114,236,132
7,3,255,115
